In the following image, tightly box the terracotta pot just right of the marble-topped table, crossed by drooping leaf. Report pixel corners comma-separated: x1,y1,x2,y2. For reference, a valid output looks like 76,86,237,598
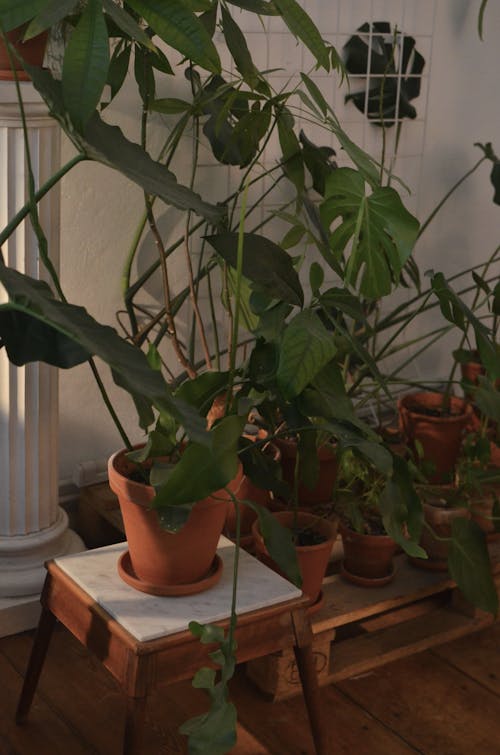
252,511,338,604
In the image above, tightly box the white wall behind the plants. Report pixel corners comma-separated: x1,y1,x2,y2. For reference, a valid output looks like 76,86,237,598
56,0,500,478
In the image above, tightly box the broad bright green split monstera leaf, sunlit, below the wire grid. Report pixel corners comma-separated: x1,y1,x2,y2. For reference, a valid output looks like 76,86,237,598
320,168,419,299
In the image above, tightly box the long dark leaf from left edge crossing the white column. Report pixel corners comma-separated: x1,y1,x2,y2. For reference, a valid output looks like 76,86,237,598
0,262,209,443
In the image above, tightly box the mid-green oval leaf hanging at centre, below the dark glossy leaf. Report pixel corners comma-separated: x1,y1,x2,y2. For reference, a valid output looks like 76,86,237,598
276,309,337,399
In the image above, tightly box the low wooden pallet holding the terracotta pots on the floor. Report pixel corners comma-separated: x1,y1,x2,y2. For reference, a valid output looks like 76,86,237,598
247,543,500,700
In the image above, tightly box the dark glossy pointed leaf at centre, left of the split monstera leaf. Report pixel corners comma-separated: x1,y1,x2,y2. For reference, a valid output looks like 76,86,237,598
206,232,304,306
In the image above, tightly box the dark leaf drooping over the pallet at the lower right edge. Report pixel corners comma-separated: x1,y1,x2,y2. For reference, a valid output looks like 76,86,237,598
448,517,498,616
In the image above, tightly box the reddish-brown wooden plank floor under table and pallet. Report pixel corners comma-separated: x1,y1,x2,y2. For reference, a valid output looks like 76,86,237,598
0,624,500,755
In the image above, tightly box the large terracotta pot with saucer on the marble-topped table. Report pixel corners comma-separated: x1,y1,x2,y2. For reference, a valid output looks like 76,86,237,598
108,451,242,595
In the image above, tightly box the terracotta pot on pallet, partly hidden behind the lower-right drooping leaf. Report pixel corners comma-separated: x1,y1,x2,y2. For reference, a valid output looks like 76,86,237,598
410,501,470,571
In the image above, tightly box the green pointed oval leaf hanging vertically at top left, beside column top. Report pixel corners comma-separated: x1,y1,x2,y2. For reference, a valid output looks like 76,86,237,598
62,0,109,129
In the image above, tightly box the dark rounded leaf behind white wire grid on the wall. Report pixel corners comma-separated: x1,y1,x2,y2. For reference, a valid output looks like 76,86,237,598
343,21,425,126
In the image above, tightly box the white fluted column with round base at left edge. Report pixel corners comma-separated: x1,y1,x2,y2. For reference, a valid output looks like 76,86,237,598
0,82,83,636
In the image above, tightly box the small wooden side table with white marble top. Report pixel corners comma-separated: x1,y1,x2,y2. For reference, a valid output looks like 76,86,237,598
16,538,331,755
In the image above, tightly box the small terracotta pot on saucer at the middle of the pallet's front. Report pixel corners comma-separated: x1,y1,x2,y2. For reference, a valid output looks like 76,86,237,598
339,523,398,587
